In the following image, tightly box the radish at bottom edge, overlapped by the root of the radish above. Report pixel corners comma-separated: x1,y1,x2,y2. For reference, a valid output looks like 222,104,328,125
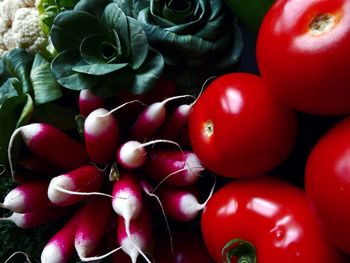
117,209,153,263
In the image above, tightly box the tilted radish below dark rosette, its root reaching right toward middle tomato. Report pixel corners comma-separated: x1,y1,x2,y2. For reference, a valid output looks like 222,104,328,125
130,95,192,141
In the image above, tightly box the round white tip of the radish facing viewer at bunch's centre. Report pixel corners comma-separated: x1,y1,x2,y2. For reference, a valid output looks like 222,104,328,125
118,141,147,169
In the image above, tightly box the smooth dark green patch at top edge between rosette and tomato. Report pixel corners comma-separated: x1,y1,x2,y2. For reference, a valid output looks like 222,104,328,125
225,0,275,32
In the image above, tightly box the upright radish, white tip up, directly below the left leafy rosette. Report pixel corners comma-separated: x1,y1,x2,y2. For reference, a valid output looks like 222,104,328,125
84,108,118,165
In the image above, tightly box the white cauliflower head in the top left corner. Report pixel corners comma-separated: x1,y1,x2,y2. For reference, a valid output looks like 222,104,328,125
0,0,47,57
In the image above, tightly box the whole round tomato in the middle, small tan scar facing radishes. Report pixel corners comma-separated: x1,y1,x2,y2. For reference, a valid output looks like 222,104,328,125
189,73,296,178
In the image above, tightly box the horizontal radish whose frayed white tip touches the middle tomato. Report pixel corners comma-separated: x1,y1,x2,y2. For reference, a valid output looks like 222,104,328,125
143,150,204,186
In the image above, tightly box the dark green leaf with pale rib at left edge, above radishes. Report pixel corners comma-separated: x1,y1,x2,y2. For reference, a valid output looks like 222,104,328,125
0,94,33,165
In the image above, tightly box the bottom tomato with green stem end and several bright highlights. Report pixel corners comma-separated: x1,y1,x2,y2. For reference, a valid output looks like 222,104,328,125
201,176,345,263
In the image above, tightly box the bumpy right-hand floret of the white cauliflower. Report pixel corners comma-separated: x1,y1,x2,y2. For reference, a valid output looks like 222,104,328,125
6,7,47,53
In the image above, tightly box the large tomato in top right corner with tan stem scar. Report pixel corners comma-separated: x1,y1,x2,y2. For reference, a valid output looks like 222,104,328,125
257,0,350,115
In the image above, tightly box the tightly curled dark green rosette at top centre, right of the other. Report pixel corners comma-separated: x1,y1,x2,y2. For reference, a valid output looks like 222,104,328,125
134,0,243,87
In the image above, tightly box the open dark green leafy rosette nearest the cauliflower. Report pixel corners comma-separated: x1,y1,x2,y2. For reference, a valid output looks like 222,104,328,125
50,0,164,97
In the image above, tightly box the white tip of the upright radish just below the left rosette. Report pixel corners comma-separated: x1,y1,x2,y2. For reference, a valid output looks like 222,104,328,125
84,108,113,136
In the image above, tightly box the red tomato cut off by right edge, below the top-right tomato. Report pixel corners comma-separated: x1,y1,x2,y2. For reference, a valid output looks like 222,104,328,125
305,118,350,254
